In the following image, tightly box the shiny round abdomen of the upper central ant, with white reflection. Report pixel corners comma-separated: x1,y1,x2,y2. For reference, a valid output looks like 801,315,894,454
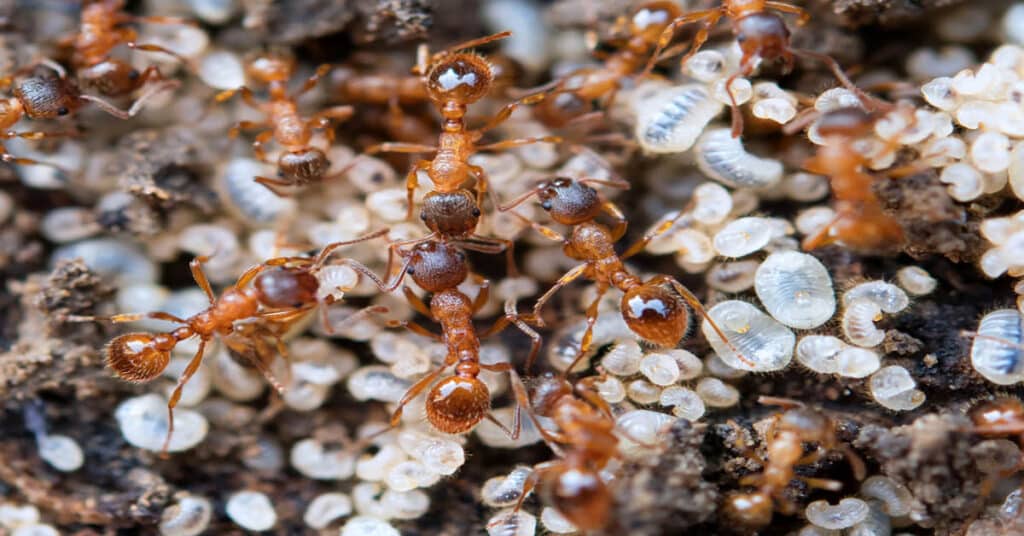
427,53,494,105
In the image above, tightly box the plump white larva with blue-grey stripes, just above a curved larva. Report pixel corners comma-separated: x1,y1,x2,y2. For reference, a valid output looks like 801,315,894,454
633,84,722,153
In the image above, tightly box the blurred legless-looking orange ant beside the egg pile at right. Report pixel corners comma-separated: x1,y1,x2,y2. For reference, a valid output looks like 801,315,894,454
803,108,913,254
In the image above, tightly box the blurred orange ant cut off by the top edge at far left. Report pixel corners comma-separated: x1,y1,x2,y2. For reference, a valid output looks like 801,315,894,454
59,0,195,96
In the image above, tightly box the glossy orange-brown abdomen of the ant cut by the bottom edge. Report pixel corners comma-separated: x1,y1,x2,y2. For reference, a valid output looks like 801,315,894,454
541,467,612,531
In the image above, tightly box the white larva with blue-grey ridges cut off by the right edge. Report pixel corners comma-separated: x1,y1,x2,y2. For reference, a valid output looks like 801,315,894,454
971,308,1024,385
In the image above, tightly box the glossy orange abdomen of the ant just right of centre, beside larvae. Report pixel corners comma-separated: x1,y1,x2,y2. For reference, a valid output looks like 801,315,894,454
621,284,690,347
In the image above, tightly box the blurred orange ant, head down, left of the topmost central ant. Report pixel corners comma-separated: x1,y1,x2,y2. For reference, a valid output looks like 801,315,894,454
214,52,353,197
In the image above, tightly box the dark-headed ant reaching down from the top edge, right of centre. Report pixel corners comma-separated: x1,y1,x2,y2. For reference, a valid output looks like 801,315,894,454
644,0,876,137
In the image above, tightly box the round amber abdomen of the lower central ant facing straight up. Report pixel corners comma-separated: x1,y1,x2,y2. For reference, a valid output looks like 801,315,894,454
426,376,490,434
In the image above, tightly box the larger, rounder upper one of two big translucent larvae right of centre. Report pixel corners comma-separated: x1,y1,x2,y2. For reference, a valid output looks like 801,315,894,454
754,251,836,329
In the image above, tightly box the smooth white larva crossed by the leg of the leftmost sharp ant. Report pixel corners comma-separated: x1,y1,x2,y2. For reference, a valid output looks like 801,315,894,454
114,395,210,452
